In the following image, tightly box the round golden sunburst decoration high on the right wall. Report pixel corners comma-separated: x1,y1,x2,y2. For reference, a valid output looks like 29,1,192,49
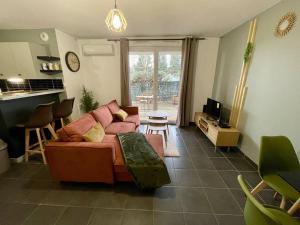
275,12,297,37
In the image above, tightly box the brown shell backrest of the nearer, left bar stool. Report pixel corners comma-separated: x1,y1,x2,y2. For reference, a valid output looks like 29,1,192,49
25,102,54,128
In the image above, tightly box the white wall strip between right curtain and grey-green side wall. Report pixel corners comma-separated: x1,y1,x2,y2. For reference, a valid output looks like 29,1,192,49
191,38,219,121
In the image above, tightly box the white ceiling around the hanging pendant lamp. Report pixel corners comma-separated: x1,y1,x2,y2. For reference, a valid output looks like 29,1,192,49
0,0,280,38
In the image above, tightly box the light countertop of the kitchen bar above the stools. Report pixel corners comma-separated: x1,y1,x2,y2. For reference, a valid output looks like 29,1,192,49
0,89,65,101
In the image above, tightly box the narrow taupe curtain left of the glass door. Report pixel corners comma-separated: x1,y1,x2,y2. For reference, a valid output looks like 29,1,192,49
120,38,131,106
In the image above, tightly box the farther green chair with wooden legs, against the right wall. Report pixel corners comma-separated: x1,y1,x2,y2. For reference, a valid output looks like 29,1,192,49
251,136,300,209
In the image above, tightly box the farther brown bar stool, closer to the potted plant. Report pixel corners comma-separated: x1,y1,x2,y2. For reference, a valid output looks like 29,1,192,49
52,98,75,129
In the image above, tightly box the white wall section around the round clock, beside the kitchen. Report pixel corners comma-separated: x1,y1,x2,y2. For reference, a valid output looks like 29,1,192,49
55,30,86,119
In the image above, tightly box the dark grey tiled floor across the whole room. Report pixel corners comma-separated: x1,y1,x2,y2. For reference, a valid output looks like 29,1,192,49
0,127,278,225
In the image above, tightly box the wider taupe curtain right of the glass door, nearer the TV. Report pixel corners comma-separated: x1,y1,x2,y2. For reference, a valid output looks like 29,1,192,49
176,37,198,127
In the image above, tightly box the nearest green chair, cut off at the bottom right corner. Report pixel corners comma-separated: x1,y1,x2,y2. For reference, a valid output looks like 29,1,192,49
238,175,300,225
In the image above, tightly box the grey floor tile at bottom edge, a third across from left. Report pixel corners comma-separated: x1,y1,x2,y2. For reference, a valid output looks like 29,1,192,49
89,209,123,225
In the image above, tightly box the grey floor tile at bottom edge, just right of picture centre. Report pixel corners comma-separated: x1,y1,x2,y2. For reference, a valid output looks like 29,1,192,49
154,212,184,225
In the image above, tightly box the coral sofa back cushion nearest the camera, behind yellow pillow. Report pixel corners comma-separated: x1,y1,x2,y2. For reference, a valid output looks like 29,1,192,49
57,114,97,142
